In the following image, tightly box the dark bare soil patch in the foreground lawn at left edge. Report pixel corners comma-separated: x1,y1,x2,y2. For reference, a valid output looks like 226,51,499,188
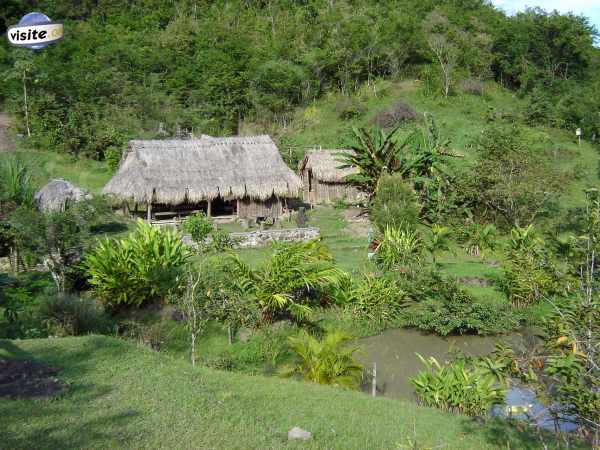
0,359,67,399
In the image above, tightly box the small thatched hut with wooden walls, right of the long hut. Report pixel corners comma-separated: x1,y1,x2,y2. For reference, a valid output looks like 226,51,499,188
298,149,364,205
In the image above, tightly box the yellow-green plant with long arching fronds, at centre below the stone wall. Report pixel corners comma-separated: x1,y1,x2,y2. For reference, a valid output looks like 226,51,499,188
227,240,342,321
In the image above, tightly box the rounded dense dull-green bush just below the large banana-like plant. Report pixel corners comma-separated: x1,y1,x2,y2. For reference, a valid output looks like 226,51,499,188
371,174,421,233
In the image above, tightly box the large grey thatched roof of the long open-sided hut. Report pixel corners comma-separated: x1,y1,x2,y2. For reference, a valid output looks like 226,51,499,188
103,136,302,205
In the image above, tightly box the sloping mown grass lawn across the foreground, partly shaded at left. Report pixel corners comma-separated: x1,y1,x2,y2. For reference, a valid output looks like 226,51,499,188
0,336,556,450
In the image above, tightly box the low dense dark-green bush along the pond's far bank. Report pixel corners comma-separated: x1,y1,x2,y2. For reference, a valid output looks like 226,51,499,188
403,273,520,336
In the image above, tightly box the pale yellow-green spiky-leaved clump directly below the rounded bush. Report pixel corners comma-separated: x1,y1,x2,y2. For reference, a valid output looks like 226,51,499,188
375,226,423,271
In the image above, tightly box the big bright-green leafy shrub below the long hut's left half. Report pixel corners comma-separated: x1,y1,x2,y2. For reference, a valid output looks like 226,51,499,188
83,220,190,306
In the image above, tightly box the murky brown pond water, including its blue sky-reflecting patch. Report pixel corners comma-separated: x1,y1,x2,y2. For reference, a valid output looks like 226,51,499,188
359,328,575,431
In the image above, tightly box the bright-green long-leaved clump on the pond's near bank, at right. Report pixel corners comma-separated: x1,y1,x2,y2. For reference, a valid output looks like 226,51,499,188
410,354,506,417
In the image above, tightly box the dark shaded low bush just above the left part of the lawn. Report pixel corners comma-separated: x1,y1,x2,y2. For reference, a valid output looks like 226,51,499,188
37,294,113,336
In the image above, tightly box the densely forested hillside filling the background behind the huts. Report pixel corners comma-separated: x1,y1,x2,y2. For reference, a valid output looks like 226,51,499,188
0,0,600,160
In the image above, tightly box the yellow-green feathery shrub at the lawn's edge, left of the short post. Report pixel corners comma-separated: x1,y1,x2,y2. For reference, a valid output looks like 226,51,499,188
281,330,363,389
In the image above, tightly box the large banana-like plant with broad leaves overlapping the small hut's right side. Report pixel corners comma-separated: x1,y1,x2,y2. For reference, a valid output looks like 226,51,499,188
339,127,412,198
